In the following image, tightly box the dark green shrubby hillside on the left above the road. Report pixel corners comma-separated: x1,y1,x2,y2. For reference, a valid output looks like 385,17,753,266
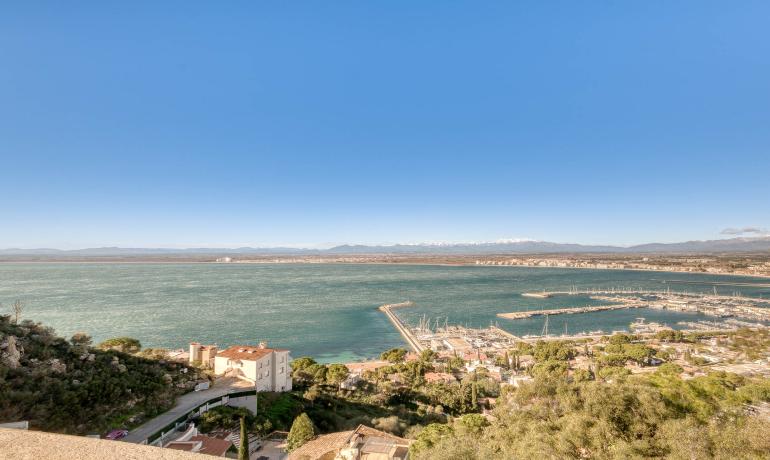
0,316,200,434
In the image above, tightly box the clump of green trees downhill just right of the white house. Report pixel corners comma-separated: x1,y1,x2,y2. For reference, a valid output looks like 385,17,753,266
282,349,500,435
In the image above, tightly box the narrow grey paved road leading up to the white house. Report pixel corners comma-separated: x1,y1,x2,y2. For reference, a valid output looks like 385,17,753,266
122,377,253,443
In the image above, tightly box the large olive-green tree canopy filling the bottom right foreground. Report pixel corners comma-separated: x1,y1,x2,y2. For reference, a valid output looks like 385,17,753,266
411,364,770,459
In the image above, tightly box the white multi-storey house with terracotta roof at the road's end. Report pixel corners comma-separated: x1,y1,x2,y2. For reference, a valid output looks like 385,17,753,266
214,342,291,391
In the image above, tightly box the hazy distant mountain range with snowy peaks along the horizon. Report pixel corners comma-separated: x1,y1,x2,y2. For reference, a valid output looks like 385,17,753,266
0,237,770,257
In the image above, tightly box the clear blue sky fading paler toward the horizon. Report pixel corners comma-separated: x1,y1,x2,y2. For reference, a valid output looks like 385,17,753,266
0,0,770,248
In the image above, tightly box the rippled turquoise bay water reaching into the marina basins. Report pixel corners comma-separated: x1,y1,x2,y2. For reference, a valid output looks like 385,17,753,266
0,263,770,361
